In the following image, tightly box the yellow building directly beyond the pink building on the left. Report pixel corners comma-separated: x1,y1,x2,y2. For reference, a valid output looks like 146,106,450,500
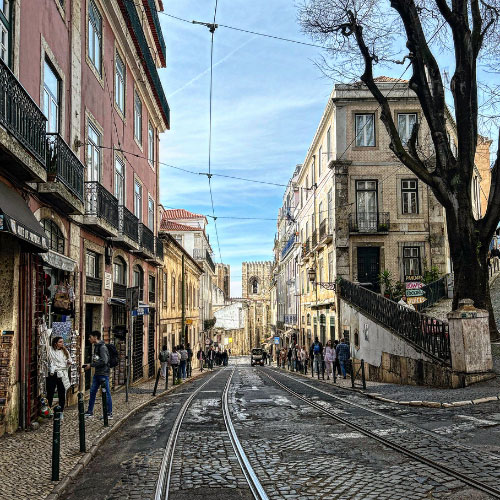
158,233,203,350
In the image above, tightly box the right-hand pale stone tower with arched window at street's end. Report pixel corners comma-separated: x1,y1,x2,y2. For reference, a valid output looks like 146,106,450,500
241,261,272,348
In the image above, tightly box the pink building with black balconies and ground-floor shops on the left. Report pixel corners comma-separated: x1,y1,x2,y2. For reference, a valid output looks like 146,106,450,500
0,0,170,434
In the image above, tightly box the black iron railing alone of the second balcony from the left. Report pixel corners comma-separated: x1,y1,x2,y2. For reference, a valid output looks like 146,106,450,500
47,133,84,201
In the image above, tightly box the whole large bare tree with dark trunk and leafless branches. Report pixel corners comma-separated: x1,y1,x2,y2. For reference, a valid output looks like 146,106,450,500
299,0,500,339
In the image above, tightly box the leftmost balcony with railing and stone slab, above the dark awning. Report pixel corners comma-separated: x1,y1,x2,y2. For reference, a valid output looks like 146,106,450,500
0,59,47,182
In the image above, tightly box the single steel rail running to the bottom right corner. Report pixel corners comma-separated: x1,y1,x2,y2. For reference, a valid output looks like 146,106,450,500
263,372,500,498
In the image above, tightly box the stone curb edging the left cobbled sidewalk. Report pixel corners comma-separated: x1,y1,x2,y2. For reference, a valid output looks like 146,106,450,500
45,370,212,500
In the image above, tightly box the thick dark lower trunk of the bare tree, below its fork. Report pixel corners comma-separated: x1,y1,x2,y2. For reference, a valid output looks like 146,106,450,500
446,208,499,341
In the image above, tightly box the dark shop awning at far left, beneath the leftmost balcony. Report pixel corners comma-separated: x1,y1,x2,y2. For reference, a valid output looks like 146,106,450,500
0,182,49,252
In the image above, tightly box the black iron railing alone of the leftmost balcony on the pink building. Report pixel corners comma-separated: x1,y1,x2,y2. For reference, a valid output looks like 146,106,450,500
0,59,47,167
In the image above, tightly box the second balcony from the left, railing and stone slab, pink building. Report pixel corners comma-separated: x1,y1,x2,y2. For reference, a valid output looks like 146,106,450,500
38,134,84,215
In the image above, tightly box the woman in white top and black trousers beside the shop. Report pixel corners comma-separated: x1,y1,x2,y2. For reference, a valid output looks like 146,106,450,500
46,337,72,420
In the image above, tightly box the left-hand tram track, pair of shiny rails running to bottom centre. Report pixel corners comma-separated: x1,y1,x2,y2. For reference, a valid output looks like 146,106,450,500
154,368,268,500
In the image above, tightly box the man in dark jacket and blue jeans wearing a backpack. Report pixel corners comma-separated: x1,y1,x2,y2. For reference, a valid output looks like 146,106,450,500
83,330,113,419
